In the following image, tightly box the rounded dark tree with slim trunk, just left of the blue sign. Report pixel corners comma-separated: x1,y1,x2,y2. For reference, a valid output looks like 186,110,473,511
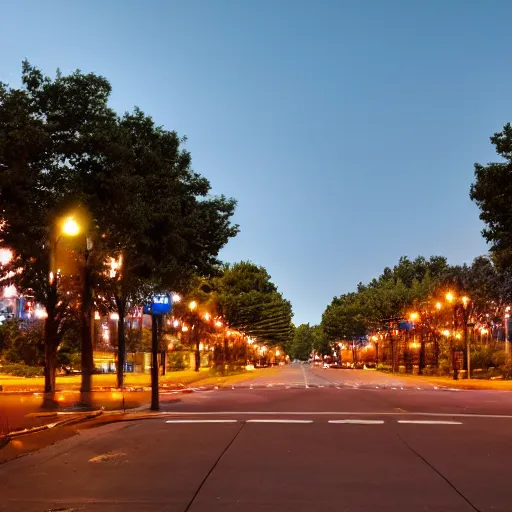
81,109,238,387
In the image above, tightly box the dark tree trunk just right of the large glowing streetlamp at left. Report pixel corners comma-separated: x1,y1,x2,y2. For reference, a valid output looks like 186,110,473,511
80,254,94,407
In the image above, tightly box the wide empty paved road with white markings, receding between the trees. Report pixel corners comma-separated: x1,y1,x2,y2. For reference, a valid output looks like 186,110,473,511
0,366,512,512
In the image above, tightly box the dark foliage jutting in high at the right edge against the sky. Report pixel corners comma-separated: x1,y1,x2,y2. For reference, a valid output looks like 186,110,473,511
469,123,512,268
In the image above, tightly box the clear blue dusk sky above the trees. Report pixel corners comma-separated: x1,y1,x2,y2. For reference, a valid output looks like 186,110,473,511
0,0,512,323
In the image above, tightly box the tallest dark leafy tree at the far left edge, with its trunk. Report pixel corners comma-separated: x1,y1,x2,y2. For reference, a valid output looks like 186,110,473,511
0,62,113,402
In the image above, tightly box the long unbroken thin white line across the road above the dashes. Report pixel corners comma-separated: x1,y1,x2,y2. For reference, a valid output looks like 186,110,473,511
160,411,512,420
